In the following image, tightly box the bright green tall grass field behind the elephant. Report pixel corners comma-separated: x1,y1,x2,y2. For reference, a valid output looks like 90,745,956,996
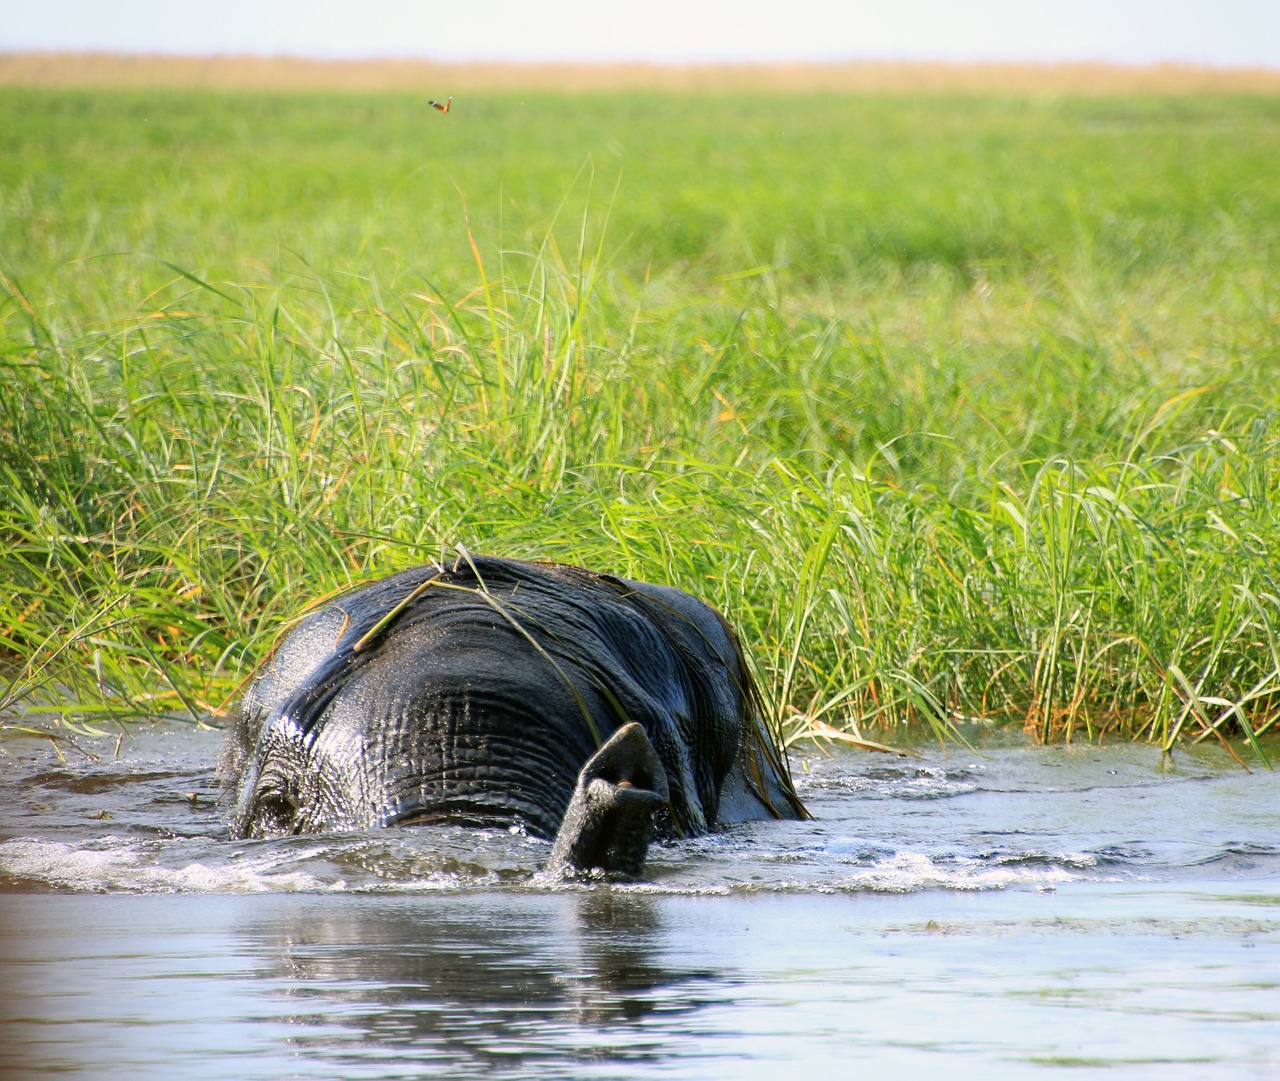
0,80,1280,743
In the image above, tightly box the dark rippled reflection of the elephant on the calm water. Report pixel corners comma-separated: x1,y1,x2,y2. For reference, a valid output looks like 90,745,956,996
247,892,714,1076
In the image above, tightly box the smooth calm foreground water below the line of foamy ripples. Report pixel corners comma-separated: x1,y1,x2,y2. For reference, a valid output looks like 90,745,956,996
0,883,1280,1081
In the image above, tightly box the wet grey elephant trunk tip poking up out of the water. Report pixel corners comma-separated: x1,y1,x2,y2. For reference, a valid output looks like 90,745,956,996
547,723,669,879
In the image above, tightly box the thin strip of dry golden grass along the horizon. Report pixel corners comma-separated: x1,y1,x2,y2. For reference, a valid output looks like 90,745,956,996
0,52,1280,95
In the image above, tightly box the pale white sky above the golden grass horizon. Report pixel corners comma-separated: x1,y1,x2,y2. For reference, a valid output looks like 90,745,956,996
0,0,1280,68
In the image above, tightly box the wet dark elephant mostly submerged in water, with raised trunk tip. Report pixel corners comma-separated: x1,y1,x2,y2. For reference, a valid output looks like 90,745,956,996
224,556,806,876
